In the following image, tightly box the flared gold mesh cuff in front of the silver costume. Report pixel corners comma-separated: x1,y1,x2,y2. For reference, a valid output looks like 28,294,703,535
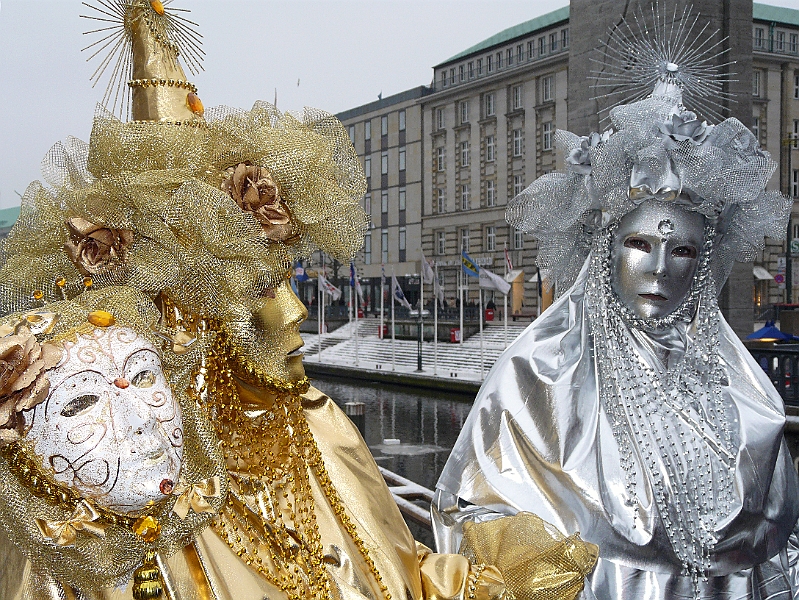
460,512,599,600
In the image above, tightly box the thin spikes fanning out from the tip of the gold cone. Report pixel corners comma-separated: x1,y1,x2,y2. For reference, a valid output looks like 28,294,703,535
81,0,205,116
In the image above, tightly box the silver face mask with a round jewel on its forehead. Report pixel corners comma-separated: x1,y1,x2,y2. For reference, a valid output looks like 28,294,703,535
610,201,705,319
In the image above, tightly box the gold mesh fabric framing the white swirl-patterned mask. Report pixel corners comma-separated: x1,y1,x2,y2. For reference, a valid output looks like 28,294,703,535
0,287,228,597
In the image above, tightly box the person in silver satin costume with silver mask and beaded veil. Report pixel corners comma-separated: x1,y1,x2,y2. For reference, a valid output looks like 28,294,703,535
433,8,799,600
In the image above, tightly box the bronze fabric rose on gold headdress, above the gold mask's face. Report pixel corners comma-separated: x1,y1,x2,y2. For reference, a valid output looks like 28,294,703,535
222,163,294,242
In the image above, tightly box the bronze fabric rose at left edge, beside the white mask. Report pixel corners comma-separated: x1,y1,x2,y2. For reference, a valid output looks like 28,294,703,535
0,326,62,444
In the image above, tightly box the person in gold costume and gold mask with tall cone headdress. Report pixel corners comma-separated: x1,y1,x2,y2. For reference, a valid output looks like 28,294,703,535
0,0,590,600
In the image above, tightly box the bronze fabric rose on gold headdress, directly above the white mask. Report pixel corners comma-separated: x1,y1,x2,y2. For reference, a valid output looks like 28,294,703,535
64,217,133,275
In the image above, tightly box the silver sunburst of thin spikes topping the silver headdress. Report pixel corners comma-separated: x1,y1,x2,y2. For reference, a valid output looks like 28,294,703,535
590,2,736,121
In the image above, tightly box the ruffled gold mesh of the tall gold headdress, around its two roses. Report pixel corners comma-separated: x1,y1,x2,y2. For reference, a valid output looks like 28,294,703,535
0,103,367,321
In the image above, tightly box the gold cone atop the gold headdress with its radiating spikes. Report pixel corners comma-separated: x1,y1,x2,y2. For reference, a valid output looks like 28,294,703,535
81,0,205,122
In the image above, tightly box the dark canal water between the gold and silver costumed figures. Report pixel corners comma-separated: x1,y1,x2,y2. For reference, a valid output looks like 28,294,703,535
312,377,474,547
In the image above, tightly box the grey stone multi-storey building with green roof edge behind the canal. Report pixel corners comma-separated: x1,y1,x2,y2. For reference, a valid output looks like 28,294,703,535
339,0,799,332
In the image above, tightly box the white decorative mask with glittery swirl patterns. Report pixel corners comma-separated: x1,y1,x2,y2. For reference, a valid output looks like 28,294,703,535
25,327,183,513
